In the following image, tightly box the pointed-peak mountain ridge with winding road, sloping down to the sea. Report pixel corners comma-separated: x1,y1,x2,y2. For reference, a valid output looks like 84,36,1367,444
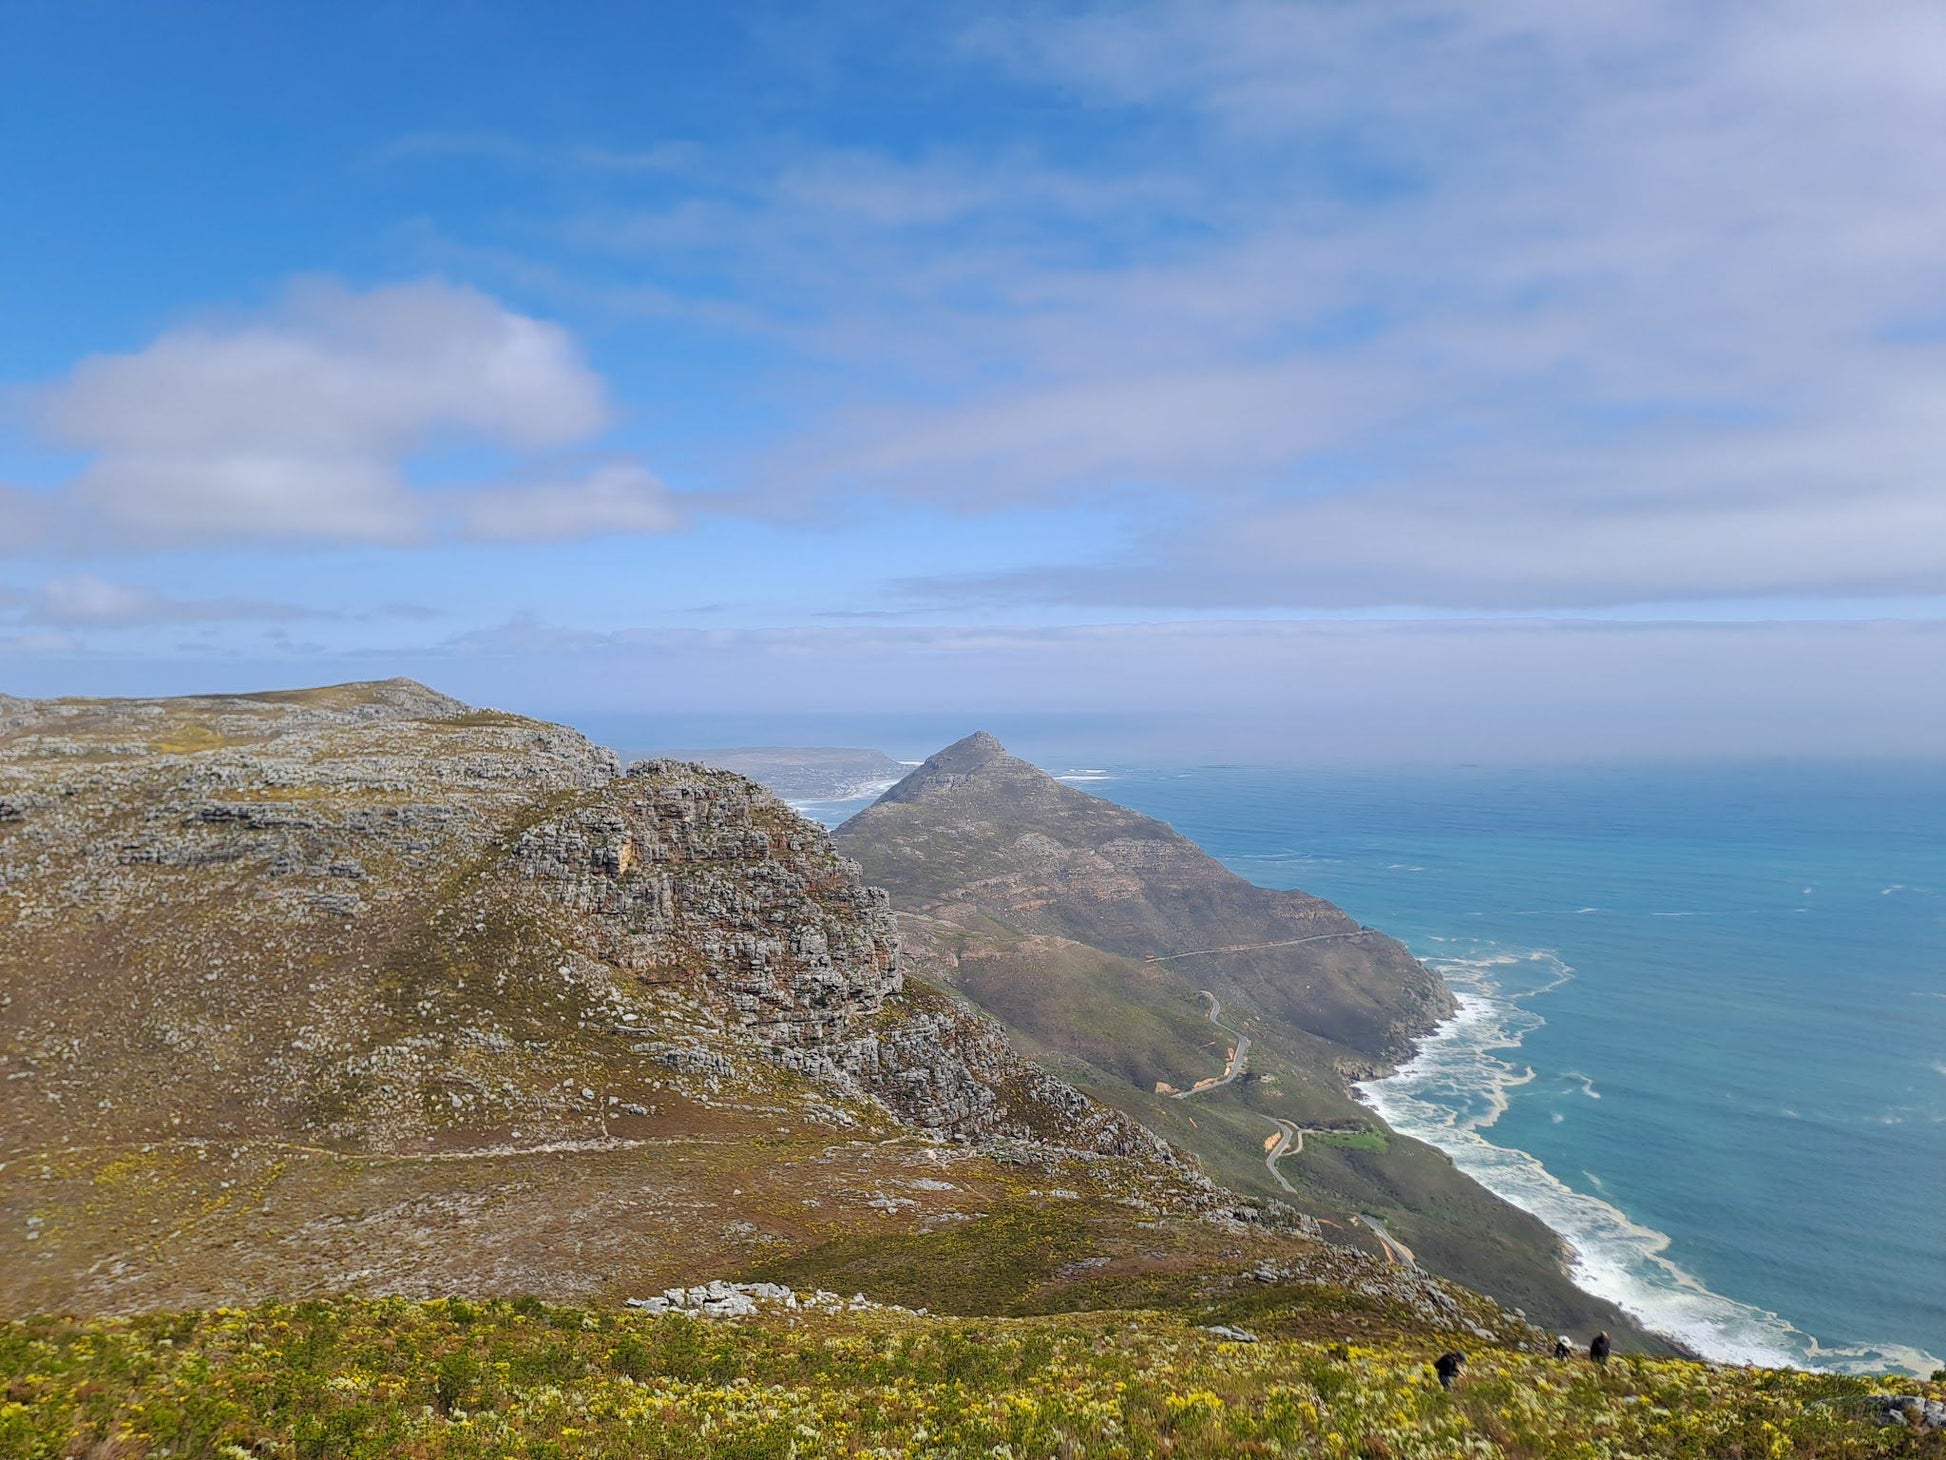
833,732,1658,1345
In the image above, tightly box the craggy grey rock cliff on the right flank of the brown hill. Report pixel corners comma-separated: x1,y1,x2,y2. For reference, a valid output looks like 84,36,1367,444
512,761,1170,1160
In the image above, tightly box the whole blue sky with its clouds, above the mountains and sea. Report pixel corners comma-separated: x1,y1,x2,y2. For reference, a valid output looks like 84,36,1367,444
0,0,1946,757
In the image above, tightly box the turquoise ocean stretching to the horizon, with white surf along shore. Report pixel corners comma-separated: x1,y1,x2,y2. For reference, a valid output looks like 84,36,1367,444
806,755,1946,1372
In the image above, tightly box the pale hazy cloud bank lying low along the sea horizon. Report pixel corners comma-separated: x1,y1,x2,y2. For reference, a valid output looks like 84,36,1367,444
0,619,1946,765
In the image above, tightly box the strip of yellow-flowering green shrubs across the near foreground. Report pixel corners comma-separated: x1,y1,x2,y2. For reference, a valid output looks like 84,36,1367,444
0,1298,1946,1460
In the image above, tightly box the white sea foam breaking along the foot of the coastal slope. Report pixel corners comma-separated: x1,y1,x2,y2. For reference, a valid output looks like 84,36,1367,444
1356,948,1940,1372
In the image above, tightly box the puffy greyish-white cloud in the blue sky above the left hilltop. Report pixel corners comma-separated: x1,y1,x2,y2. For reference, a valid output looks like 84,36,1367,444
24,282,669,545
